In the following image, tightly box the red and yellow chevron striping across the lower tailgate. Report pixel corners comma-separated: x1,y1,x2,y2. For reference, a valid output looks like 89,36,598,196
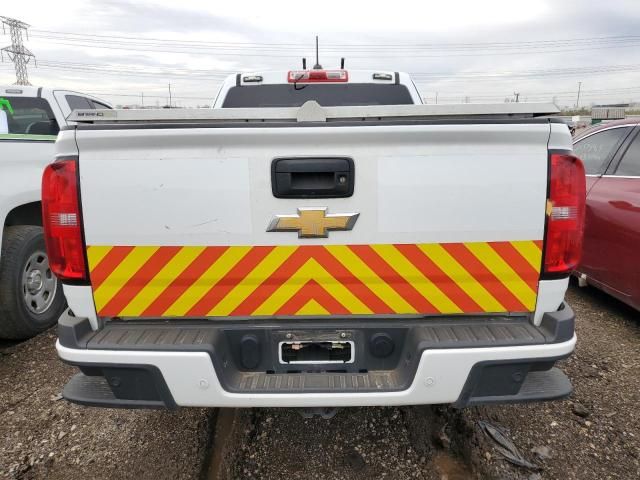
87,241,542,317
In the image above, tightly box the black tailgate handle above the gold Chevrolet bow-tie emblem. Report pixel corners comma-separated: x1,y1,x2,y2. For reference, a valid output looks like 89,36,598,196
271,157,355,198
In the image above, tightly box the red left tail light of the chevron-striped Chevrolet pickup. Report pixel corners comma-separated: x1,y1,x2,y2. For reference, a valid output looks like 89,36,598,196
42,159,88,281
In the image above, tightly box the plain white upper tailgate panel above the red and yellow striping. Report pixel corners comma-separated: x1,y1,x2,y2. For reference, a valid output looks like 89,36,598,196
77,124,549,245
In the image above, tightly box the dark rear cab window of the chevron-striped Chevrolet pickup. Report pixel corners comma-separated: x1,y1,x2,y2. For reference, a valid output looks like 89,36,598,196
222,83,413,108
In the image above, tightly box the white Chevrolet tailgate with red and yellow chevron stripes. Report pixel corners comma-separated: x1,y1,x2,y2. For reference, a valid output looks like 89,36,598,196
76,122,550,318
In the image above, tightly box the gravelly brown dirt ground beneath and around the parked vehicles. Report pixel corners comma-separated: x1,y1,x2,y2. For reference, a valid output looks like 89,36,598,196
0,286,640,480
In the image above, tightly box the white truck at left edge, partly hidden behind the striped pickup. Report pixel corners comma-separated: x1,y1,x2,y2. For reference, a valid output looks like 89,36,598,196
0,85,110,339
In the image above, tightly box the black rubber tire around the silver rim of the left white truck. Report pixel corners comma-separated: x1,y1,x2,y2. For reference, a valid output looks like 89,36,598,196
0,225,66,340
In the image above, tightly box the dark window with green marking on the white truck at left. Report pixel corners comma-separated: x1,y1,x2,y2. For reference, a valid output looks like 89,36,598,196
0,97,60,135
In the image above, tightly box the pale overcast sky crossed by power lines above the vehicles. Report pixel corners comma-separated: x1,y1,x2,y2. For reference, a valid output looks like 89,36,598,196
0,0,640,106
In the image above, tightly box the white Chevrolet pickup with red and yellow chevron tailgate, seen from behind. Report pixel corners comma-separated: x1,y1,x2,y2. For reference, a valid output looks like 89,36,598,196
43,70,585,409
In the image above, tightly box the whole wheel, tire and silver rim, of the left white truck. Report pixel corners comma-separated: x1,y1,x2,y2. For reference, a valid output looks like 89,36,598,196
0,225,66,340
